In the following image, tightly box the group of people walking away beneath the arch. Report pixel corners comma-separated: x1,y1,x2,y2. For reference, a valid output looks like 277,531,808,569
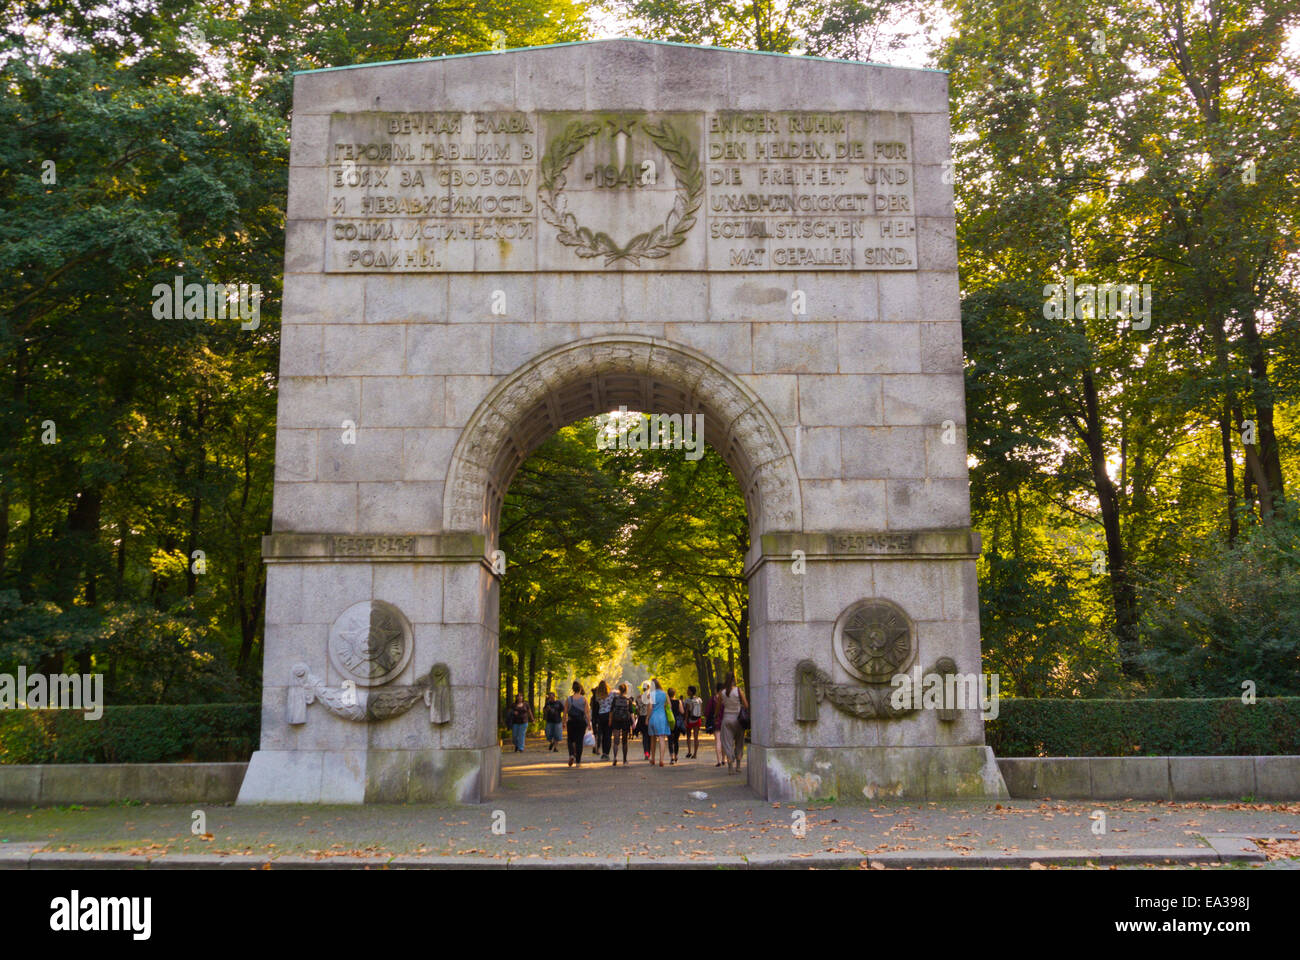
508,674,749,773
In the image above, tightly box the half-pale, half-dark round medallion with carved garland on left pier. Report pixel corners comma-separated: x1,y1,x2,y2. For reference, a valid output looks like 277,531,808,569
286,600,451,725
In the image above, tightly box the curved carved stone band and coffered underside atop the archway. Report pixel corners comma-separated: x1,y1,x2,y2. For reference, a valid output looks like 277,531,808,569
443,336,802,544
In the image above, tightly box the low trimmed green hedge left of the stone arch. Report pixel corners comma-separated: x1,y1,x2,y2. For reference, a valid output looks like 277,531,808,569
0,704,261,764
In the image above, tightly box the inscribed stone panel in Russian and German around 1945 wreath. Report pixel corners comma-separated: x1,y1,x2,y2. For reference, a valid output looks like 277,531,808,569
324,111,917,273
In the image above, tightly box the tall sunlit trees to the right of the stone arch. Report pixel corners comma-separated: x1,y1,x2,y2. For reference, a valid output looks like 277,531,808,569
941,0,1300,689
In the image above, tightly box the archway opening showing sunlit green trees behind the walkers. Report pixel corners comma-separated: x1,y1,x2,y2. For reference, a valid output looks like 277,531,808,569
498,407,749,790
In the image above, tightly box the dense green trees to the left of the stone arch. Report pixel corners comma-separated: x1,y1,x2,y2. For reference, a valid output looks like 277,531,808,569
0,0,586,695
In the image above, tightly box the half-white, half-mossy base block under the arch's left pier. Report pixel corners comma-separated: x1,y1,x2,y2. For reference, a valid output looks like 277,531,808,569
237,747,501,804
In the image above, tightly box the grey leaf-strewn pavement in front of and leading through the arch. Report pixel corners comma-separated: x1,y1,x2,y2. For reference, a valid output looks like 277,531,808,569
0,743,1300,866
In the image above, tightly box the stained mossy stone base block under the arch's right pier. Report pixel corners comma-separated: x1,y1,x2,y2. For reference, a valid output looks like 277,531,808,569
746,745,1010,803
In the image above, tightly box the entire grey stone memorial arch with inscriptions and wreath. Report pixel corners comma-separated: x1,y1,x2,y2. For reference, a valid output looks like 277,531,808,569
239,40,1006,803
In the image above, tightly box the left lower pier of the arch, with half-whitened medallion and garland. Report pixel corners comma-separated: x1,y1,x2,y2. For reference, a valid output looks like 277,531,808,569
238,535,501,804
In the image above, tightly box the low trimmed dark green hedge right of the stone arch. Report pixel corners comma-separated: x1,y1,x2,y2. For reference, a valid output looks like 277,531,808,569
984,697,1300,757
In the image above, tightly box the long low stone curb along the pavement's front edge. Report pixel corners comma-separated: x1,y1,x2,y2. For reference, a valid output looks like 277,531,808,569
0,836,1266,870
